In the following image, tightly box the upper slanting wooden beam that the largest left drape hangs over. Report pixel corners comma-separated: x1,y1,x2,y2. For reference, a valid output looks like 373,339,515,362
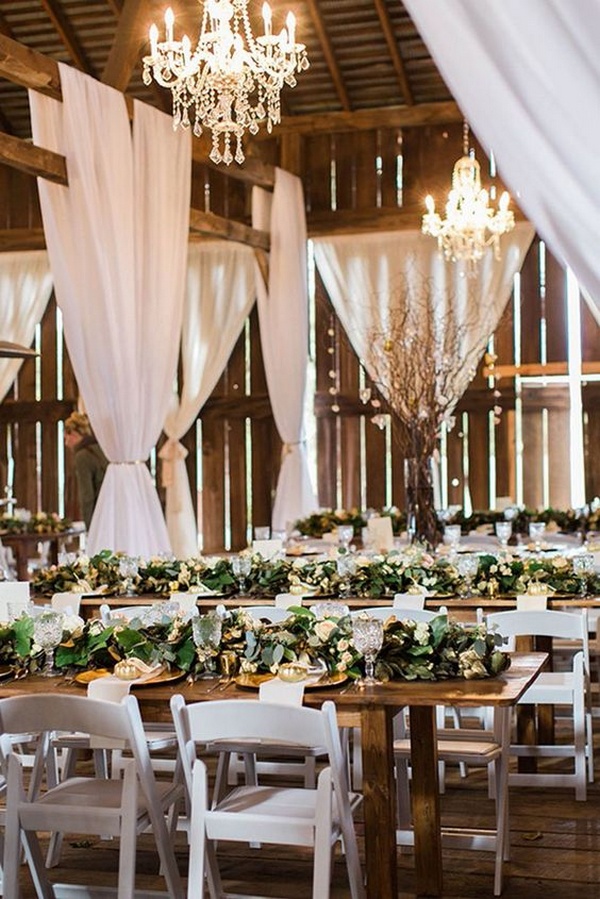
0,34,275,189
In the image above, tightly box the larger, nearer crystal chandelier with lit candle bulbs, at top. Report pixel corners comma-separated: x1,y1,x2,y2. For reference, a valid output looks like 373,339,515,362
143,0,308,165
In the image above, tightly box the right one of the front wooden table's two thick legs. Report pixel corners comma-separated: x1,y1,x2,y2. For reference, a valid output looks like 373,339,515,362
410,706,442,896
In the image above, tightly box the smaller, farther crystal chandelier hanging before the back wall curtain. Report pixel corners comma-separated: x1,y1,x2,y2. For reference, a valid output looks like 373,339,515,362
421,122,515,275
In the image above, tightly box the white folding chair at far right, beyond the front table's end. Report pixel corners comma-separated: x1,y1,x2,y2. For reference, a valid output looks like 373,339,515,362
486,609,594,800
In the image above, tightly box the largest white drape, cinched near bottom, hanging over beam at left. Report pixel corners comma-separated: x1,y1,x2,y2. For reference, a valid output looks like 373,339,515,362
29,64,191,557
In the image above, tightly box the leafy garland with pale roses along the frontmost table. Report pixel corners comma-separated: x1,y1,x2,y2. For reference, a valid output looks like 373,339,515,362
0,607,509,681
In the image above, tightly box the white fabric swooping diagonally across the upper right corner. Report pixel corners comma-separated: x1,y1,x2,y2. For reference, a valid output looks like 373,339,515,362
406,0,600,305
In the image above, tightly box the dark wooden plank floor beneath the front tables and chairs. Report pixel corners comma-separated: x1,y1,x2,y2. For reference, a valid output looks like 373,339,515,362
10,740,600,899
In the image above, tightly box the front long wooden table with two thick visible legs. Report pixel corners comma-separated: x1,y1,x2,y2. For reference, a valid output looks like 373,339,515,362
0,653,547,899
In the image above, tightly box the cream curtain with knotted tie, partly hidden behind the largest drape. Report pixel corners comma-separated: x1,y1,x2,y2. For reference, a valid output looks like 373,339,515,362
159,241,256,559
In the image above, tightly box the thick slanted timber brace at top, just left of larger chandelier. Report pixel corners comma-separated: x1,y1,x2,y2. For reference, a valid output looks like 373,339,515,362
101,0,153,92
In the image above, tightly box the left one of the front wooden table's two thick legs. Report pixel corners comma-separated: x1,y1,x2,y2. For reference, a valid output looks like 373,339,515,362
361,706,398,899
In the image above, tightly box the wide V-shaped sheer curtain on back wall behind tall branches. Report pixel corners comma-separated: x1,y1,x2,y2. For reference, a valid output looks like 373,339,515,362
314,222,534,420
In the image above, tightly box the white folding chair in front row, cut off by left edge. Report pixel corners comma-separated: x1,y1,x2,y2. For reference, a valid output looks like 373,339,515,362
0,695,183,899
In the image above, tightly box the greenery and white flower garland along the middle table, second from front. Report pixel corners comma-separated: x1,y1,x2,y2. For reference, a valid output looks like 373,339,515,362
33,547,600,599
